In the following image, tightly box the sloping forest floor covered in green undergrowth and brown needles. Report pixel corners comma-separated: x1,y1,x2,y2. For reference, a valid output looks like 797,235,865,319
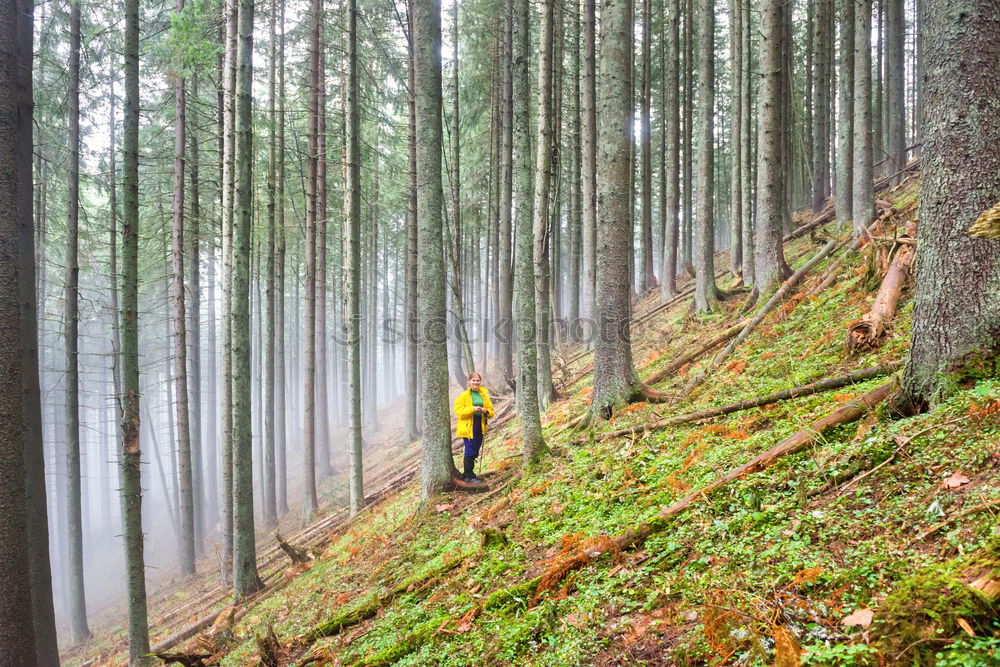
67,178,1000,667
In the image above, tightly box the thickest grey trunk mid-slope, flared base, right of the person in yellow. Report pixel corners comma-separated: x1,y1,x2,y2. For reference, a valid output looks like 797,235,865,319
591,0,638,418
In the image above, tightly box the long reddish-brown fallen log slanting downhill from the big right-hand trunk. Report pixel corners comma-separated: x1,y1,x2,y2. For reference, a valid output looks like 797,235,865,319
548,378,898,593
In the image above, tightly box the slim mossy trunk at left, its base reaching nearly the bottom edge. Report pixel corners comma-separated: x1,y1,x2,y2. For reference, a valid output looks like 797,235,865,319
120,0,149,652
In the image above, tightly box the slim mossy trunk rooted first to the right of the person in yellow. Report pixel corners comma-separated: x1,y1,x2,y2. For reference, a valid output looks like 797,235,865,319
512,0,552,465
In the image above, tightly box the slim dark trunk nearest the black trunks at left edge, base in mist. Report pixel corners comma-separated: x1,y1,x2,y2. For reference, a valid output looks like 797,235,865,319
63,2,90,645
